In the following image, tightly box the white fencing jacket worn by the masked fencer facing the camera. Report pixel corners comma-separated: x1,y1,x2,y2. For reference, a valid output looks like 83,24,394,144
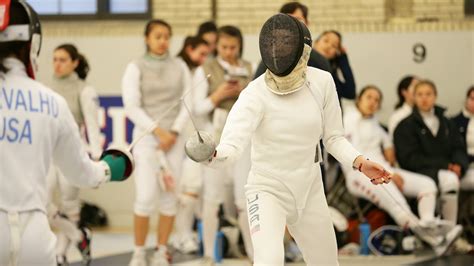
210,67,360,208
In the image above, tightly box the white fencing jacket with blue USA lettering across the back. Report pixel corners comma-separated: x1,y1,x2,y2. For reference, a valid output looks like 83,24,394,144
0,58,110,212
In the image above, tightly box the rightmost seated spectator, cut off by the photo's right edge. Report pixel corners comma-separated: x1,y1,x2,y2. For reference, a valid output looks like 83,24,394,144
452,86,474,190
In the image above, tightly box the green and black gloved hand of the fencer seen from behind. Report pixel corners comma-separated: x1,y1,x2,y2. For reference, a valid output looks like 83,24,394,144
100,148,135,181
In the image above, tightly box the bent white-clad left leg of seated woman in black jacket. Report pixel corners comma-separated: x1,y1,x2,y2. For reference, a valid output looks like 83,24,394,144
395,169,438,224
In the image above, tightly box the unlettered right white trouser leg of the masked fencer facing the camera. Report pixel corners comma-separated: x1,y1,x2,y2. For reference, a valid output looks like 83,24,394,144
288,180,338,265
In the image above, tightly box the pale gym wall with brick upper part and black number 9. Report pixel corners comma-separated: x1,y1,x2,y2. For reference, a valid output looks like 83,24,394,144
39,0,474,229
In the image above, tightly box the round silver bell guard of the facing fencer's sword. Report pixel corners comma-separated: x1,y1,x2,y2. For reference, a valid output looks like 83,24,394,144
184,131,216,163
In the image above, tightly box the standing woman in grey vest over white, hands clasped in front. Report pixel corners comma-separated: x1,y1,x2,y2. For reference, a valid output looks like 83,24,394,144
122,19,191,266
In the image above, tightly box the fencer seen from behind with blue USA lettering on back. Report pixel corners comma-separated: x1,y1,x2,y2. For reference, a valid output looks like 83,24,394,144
0,0,133,266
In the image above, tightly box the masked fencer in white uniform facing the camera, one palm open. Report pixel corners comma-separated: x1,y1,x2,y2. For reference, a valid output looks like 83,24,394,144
188,14,391,265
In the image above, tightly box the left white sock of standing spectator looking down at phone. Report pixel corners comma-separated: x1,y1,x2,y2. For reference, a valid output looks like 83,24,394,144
202,201,219,258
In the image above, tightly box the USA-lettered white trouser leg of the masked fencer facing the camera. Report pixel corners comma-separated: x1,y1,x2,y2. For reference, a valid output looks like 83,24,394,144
246,189,291,266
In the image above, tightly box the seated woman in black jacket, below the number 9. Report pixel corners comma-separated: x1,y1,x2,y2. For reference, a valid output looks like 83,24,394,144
393,80,469,224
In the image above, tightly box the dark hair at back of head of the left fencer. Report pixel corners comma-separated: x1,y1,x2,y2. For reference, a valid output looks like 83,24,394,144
0,2,30,72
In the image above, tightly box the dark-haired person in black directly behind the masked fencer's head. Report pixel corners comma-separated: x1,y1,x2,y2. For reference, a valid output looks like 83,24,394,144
254,2,331,79
